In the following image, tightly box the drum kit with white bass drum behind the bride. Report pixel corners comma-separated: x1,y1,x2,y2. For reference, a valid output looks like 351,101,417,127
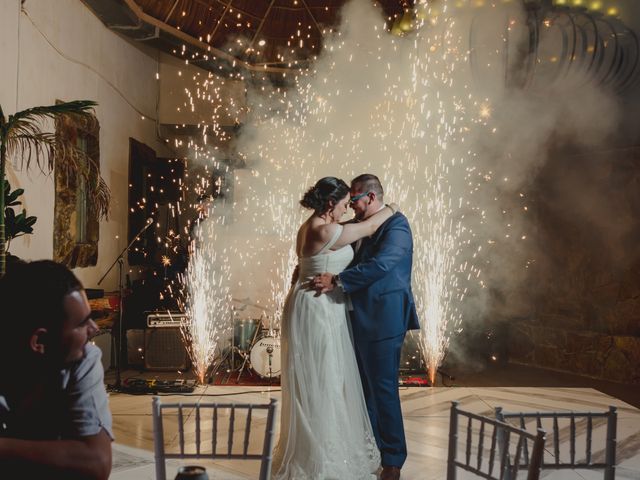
216,302,280,382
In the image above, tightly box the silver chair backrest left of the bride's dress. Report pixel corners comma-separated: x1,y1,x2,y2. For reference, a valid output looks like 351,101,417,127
153,396,277,480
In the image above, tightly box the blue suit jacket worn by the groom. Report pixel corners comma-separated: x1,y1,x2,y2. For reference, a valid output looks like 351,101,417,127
339,212,420,340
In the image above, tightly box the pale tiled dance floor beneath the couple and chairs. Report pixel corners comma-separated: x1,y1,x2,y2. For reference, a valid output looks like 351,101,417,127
110,386,640,480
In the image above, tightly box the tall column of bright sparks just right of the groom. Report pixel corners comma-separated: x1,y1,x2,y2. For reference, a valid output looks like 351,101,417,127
410,2,480,385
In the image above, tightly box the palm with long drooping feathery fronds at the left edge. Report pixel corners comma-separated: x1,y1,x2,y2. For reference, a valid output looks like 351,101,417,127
0,100,111,277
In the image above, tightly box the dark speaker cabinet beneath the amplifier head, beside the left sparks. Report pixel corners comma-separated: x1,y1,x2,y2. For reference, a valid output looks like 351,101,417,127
144,327,189,370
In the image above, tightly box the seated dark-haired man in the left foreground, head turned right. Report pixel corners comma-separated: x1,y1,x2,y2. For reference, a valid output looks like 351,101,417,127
0,260,113,480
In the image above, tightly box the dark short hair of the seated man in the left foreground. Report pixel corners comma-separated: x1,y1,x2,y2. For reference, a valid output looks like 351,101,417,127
0,260,84,349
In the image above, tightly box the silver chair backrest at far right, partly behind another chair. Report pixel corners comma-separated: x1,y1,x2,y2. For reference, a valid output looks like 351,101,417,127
495,406,618,480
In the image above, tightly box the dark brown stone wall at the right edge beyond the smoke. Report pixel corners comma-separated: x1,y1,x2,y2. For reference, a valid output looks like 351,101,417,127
508,144,640,383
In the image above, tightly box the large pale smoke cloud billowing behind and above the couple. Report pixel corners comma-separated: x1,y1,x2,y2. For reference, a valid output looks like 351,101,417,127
191,1,622,372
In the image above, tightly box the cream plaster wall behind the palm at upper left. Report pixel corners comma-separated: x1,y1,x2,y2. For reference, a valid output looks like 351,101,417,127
0,0,170,291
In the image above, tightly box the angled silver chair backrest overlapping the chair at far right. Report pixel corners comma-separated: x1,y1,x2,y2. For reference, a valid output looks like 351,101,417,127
447,402,545,480
